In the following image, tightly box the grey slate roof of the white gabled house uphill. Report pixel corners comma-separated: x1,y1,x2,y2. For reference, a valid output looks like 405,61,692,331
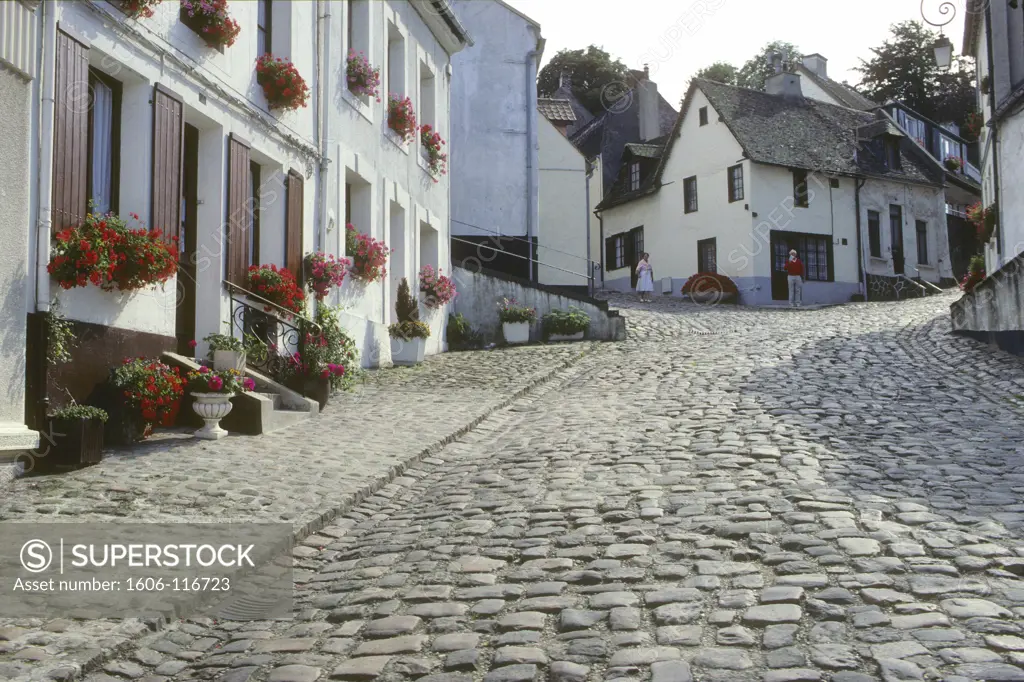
598,79,942,210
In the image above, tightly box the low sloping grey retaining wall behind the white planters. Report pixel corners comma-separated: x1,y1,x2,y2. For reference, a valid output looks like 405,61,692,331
452,267,626,342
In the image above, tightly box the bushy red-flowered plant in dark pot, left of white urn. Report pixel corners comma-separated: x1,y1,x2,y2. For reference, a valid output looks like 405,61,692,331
105,357,184,445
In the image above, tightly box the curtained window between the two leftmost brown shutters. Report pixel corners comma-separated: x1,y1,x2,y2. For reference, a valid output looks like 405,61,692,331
88,69,121,213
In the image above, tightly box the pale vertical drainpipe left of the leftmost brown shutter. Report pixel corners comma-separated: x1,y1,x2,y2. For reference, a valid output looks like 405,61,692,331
36,2,57,312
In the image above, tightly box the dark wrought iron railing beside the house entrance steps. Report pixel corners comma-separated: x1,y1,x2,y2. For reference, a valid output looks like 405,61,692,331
224,281,322,379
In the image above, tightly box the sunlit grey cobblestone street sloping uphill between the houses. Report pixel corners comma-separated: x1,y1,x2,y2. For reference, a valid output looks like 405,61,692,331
0,295,1024,682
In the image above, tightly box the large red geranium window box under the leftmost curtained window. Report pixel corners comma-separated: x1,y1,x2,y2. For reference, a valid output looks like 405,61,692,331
46,213,178,291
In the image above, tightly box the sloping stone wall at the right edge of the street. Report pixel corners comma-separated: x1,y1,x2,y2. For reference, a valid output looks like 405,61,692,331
949,254,1024,355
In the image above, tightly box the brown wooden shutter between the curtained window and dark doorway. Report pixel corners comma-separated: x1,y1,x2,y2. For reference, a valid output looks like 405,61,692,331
150,84,185,242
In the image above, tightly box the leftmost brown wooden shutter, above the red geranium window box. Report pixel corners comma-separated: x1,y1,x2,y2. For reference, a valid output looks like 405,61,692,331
51,30,90,231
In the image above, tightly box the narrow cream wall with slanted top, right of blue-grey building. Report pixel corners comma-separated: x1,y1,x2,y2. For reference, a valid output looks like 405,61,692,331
538,116,593,287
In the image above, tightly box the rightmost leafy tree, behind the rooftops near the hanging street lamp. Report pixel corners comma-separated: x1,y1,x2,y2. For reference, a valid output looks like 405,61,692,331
856,20,976,127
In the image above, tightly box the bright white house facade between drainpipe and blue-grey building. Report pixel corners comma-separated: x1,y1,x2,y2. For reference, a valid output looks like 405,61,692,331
325,0,454,367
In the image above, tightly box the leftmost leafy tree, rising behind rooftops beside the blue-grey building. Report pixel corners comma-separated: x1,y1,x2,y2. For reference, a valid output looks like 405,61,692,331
537,45,629,115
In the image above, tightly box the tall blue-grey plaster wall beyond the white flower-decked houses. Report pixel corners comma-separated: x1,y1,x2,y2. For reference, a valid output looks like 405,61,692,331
452,0,543,237
